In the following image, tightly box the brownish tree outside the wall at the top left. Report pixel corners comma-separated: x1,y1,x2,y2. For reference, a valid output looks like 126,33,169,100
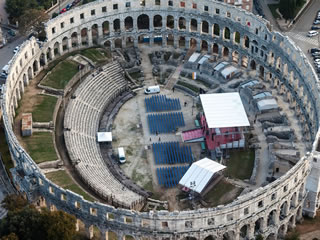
18,9,49,34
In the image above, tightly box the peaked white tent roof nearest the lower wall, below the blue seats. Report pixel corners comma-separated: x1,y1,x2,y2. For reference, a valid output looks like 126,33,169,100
179,158,226,193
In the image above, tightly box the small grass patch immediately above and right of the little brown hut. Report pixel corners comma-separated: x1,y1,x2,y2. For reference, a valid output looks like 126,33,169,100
32,95,58,122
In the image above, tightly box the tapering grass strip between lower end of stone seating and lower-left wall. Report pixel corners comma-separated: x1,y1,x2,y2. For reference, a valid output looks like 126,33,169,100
46,170,94,201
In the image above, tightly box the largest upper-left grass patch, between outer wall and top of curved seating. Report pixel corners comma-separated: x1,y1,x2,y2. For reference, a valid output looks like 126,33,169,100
41,60,78,89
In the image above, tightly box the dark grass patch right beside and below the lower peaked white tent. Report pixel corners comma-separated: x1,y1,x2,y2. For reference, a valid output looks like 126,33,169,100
204,179,242,207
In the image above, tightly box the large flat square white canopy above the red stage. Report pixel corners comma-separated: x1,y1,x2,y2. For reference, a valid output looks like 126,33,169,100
200,92,250,128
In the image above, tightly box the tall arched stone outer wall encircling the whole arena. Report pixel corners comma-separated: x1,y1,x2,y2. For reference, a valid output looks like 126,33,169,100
1,0,320,239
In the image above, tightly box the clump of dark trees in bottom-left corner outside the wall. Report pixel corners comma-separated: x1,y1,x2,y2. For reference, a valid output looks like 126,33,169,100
0,196,76,240
